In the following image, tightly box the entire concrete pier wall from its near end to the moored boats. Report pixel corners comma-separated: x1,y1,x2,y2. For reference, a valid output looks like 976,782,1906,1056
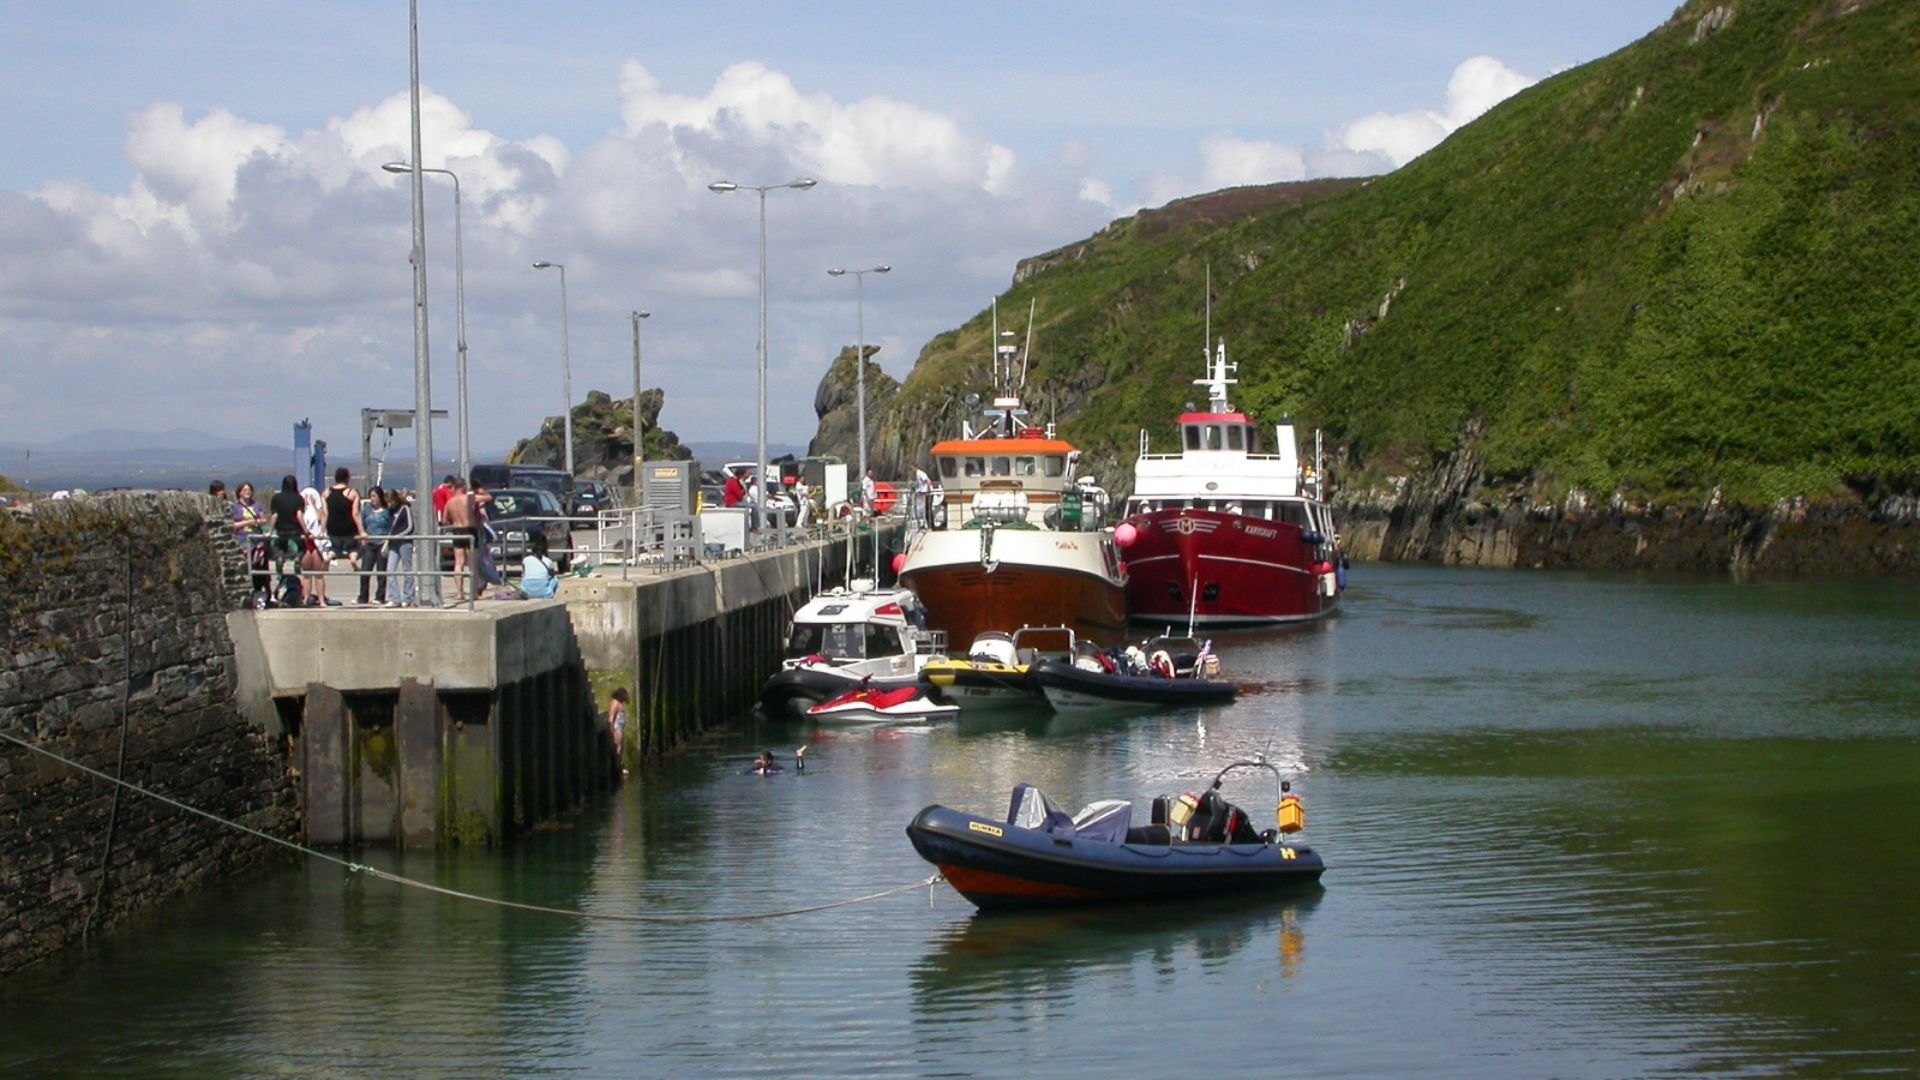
227,528,891,847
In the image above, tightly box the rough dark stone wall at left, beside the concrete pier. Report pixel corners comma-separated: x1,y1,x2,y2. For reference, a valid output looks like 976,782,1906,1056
0,494,300,974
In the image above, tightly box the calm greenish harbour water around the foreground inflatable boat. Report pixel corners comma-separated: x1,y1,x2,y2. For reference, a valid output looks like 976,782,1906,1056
0,565,1920,1076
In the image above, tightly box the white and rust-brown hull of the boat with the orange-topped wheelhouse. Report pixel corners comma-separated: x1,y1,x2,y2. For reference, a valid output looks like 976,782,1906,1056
900,528,1127,646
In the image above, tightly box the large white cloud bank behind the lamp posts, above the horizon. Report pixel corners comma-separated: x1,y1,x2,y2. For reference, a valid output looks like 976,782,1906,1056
0,61,1112,450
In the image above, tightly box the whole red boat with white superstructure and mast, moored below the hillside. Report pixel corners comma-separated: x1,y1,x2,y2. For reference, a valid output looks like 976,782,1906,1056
1114,342,1346,626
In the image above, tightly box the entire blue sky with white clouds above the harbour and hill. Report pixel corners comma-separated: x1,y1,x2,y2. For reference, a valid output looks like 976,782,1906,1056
0,0,1676,457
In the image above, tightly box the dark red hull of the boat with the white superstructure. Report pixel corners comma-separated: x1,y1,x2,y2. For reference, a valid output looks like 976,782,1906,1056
1125,509,1340,626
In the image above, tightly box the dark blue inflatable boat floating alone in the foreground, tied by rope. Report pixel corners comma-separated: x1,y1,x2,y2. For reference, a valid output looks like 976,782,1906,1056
906,761,1327,909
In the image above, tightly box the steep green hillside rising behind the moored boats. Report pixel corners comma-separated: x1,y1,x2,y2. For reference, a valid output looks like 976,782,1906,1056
877,0,1920,505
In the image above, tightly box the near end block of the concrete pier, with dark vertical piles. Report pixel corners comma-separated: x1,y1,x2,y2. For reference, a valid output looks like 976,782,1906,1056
228,600,616,847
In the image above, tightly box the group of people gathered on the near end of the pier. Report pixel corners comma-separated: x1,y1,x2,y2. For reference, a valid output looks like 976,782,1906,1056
207,467,559,607
